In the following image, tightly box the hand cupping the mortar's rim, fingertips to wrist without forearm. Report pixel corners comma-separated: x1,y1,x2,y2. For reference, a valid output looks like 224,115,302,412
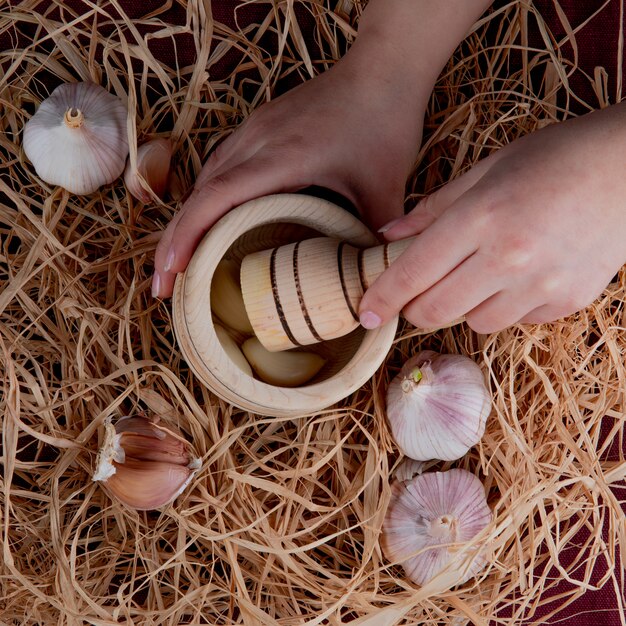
153,55,428,297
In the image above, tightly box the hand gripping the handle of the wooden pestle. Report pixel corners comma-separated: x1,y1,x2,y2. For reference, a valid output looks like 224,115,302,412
360,104,626,333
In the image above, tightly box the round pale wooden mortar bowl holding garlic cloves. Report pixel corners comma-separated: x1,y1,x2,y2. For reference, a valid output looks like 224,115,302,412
172,194,398,417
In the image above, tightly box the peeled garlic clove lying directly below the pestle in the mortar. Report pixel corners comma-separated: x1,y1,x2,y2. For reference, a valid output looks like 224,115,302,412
241,337,326,387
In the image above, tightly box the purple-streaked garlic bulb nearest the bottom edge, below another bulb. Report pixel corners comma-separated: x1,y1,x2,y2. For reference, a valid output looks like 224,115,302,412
380,469,492,587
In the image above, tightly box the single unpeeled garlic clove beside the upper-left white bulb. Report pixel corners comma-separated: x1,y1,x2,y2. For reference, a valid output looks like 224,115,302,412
124,139,173,203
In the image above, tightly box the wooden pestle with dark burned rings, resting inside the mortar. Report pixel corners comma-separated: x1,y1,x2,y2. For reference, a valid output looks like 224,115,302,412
241,237,413,352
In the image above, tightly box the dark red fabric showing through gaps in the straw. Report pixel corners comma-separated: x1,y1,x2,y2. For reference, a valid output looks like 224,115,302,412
0,0,626,626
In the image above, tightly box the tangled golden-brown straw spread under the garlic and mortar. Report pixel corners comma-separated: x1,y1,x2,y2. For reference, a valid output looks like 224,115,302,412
0,0,626,626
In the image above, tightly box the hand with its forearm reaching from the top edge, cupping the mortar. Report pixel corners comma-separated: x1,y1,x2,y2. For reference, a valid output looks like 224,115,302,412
152,0,490,297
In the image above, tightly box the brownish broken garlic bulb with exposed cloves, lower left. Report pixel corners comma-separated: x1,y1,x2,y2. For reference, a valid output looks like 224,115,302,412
93,416,200,511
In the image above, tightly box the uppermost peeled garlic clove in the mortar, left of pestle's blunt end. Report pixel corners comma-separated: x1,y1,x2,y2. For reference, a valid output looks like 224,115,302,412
211,259,253,334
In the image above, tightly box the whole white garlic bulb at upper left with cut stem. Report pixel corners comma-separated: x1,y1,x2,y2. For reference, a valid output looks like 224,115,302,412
23,83,128,194
